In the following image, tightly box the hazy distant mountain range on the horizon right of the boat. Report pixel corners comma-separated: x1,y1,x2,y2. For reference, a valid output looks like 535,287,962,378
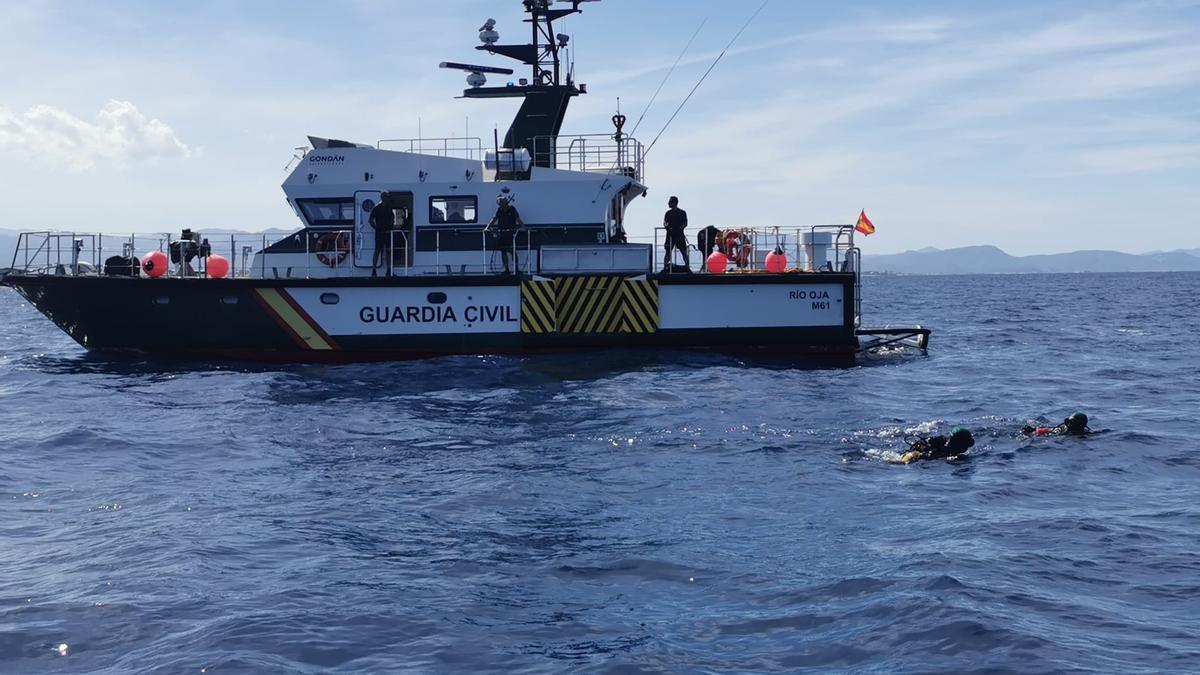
863,246,1200,274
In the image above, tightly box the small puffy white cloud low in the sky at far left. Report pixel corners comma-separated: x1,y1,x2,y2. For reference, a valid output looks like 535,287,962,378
0,100,194,169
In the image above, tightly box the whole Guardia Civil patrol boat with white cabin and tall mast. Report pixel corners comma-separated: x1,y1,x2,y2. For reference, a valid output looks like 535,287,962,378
2,0,929,362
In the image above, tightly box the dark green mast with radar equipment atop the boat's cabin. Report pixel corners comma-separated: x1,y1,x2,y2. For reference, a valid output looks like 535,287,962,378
442,0,595,168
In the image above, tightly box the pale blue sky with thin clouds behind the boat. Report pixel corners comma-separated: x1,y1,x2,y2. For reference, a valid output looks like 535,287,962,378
0,0,1200,255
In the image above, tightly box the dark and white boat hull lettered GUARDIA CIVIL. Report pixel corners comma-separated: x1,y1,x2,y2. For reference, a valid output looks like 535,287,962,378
4,274,858,363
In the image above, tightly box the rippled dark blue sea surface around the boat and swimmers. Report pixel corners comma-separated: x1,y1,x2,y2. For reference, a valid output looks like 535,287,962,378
0,274,1200,674
